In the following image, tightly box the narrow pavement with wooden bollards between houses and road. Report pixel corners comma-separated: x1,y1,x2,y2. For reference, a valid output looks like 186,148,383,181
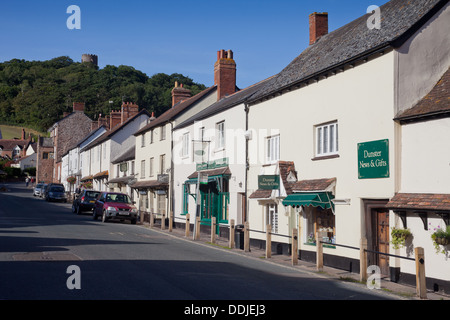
139,223,450,300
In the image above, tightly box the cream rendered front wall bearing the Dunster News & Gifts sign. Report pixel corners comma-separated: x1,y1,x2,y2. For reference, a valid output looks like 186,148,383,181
248,51,396,259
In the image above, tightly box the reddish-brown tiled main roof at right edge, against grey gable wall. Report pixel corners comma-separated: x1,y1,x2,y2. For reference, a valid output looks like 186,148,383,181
394,68,450,122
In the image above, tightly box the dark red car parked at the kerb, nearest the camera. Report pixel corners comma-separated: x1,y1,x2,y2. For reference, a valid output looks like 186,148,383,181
93,192,138,224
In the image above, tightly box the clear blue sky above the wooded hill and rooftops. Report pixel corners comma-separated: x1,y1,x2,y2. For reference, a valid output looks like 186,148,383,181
0,0,388,88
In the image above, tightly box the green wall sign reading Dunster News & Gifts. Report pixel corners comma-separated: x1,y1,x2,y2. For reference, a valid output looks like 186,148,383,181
358,139,389,179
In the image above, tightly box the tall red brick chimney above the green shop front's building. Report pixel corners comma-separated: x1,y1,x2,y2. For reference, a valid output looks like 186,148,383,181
214,50,236,100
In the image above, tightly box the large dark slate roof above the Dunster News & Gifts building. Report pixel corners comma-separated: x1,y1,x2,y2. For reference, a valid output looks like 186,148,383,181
251,0,448,102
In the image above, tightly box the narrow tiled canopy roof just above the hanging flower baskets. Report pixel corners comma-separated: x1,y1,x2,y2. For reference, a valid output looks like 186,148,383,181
386,193,450,211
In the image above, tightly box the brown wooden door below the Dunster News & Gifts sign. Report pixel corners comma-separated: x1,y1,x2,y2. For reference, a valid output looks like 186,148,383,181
374,209,390,275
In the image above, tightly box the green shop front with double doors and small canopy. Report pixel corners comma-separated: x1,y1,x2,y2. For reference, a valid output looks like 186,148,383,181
183,159,231,234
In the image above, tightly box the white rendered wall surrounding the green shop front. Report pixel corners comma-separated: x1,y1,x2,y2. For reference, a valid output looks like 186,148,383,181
173,104,245,224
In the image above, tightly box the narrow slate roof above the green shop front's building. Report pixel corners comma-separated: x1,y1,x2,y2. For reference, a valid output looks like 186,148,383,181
174,77,272,129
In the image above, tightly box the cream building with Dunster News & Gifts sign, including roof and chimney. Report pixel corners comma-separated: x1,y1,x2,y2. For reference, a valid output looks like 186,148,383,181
248,0,450,292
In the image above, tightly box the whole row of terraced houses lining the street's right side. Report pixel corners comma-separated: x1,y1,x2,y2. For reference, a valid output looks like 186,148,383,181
38,0,450,292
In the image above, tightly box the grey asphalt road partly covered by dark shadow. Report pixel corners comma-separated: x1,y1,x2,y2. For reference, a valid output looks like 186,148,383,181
0,184,393,301
